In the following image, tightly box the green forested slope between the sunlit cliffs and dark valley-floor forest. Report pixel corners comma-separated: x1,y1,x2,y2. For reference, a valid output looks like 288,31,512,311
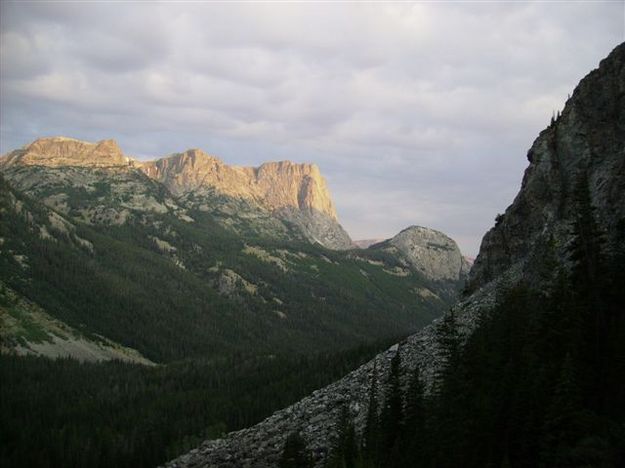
0,175,450,362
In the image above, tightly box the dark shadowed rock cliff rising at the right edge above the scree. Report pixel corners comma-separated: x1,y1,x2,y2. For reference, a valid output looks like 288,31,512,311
470,44,625,289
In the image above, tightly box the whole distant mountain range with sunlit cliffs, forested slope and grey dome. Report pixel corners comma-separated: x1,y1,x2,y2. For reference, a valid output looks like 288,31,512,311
0,133,468,362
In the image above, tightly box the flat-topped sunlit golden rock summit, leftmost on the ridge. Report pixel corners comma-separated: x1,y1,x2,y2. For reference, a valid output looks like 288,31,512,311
3,136,129,167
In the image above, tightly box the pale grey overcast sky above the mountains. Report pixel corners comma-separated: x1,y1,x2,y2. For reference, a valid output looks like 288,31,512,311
0,0,625,256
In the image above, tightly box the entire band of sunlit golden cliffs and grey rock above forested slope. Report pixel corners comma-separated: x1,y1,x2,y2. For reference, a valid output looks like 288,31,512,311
0,137,352,249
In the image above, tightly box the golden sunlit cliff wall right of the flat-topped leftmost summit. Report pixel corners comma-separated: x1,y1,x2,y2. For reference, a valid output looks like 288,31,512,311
140,149,352,249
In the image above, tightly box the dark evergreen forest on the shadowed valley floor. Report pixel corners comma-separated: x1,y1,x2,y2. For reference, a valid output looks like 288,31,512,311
0,342,390,468
